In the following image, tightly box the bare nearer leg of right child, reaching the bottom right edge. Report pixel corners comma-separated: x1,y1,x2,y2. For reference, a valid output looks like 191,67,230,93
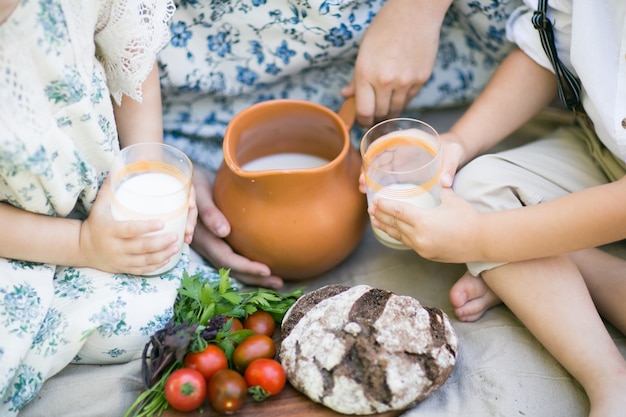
483,256,626,417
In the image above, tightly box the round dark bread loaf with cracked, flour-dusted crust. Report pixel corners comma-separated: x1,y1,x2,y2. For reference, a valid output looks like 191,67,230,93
279,285,457,414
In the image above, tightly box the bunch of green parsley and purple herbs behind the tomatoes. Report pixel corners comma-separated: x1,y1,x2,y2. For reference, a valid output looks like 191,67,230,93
125,269,302,417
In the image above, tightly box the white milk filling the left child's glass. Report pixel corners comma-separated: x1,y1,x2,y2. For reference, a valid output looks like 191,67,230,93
111,172,188,275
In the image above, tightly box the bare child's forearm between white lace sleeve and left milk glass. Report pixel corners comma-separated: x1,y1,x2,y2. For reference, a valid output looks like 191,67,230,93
113,63,163,148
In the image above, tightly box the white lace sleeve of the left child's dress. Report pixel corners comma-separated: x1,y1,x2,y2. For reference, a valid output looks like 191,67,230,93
96,0,175,105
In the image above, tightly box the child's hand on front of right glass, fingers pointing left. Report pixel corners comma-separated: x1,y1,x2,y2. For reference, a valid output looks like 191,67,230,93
368,188,482,263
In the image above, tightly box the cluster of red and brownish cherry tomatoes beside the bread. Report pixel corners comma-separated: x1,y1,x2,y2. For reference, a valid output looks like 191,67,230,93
164,310,286,414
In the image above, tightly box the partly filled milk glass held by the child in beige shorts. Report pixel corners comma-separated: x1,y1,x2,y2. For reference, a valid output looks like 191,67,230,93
361,118,441,249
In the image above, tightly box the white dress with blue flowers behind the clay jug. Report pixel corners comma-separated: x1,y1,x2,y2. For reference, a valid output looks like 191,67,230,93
159,0,521,169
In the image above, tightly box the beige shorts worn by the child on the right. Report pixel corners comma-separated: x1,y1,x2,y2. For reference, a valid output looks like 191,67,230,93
453,116,626,276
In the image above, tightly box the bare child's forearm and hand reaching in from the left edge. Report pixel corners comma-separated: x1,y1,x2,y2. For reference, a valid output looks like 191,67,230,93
0,180,178,274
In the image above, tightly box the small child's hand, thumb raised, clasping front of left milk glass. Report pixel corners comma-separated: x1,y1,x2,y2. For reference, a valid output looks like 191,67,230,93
79,178,180,275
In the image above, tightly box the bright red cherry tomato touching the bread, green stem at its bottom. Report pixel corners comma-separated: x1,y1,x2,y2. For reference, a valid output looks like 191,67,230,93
244,358,287,401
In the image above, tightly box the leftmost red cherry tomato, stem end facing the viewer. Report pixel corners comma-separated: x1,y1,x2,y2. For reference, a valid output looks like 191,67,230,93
164,368,207,411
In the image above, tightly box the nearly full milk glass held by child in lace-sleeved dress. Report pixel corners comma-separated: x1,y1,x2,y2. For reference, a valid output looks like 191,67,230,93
111,143,193,275
